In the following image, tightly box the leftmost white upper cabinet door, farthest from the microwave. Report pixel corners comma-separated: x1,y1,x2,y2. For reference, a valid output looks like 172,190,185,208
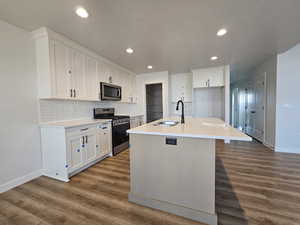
53,41,72,98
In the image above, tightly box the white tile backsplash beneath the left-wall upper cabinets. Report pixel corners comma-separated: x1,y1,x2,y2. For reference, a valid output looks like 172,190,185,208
40,100,136,123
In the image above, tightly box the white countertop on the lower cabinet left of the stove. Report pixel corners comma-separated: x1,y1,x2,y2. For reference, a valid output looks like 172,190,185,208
40,119,111,128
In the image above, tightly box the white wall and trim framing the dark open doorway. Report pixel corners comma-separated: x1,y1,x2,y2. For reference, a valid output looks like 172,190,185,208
136,71,170,120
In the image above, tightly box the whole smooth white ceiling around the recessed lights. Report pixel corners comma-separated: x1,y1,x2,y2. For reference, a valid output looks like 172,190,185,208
0,0,300,77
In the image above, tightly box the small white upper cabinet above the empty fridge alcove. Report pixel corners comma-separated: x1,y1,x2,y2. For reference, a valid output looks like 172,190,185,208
193,66,225,88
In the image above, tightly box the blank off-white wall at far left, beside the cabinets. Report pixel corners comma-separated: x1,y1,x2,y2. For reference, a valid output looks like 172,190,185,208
0,21,41,192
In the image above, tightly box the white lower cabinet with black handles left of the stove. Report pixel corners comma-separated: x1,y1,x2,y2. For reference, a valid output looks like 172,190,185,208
41,122,112,182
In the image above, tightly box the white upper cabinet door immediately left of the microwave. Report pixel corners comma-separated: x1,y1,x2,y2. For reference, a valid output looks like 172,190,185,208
85,56,100,100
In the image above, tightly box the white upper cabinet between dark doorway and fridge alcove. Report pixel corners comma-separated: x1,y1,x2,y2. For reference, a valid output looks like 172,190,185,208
171,73,193,102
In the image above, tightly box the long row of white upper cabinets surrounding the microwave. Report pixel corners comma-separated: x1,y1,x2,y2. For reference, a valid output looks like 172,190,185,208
33,28,135,103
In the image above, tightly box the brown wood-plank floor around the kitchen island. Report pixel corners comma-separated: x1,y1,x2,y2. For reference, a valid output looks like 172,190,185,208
0,142,300,225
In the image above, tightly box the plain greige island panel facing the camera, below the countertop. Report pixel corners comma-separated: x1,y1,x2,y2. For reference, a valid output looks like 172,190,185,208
130,134,215,216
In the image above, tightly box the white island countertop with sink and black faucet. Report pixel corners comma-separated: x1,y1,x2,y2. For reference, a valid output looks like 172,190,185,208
127,117,252,141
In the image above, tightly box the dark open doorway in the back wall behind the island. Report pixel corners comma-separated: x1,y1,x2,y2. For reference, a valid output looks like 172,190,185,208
146,83,163,123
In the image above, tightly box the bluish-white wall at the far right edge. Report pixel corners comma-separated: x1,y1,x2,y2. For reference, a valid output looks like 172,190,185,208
275,44,300,153
